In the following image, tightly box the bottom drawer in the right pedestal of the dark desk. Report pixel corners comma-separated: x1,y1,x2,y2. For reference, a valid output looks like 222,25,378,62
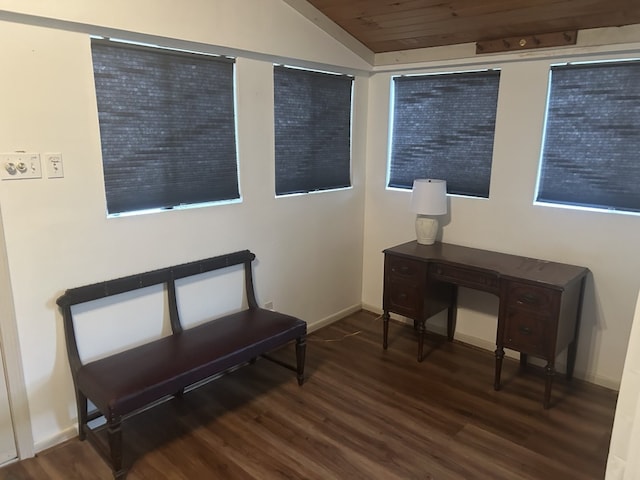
504,308,553,358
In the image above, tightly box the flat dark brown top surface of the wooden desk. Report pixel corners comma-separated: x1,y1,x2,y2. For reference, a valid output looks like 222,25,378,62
384,240,589,287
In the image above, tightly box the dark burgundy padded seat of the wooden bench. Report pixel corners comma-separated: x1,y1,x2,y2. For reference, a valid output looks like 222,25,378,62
77,308,307,418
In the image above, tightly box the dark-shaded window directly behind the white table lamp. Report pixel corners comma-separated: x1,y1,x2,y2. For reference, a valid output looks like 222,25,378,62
388,71,500,198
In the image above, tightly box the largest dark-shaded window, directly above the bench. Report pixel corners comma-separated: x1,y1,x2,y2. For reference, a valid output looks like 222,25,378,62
91,40,240,215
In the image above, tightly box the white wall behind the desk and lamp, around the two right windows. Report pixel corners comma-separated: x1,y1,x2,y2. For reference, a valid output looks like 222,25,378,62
363,33,640,388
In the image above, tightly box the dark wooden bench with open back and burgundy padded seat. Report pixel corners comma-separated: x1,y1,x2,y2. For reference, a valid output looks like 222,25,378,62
57,250,307,479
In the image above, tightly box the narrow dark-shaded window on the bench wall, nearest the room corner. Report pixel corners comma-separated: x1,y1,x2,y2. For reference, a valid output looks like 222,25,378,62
273,66,353,195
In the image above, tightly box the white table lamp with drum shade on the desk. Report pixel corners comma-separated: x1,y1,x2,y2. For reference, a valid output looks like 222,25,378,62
411,178,447,245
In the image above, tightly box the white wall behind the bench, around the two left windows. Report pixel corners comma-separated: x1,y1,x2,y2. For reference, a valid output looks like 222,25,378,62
0,0,367,450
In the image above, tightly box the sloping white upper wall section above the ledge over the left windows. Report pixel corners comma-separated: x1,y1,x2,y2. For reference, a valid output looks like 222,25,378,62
0,0,369,70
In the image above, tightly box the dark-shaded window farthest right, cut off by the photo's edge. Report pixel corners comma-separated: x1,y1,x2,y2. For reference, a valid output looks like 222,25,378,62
536,61,640,212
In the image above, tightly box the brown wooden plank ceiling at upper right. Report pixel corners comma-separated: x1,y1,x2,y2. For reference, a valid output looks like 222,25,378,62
308,0,640,53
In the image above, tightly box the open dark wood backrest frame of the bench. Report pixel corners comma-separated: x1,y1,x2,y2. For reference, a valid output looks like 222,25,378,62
56,250,258,376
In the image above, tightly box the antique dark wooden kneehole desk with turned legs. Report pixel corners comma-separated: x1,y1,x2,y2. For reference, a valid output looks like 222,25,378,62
383,241,589,408
